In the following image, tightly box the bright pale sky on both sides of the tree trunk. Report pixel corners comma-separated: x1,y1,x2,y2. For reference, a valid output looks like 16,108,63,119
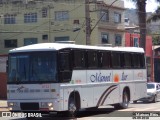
124,0,160,12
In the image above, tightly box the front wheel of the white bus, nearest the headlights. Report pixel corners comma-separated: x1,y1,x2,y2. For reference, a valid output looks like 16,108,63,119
68,97,78,117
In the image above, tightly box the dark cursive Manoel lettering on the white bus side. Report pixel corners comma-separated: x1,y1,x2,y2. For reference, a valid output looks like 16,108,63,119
90,73,111,82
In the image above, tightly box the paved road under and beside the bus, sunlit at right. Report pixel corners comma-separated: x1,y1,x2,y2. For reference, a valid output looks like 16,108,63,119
0,102,160,120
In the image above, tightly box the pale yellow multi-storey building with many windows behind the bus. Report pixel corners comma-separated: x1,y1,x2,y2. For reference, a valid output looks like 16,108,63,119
0,0,125,97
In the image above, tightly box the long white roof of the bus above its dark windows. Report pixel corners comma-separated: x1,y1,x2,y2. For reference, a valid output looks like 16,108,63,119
9,43,144,53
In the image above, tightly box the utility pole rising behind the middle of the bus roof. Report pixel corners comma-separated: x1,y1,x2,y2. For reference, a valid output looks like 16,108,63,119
85,0,91,45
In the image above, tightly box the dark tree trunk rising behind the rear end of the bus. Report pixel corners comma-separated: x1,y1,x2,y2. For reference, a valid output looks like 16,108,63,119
131,0,160,50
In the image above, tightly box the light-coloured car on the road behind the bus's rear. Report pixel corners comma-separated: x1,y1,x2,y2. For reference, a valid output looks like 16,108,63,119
133,82,160,103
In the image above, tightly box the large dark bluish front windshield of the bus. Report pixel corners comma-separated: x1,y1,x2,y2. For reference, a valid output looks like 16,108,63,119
8,51,57,84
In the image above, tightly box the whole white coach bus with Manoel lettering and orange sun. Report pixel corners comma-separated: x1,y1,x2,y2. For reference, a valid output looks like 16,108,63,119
7,43,147,114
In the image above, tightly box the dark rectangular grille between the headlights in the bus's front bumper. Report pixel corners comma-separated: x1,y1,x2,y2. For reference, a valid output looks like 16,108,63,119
20,103,39,110
